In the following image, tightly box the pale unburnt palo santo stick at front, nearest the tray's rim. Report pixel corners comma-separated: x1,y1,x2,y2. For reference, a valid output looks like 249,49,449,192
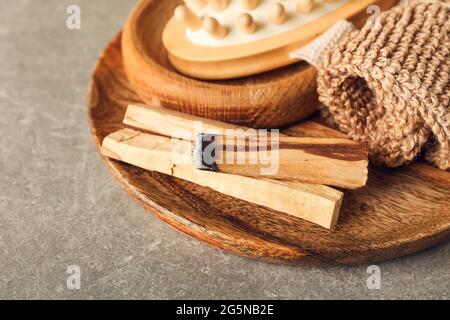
101,129,343,229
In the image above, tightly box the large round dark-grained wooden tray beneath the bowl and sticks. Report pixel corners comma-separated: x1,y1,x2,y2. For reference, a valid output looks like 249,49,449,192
88,32,450,264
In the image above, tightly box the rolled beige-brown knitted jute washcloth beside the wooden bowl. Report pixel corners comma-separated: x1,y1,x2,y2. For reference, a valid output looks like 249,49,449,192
318,1,450,170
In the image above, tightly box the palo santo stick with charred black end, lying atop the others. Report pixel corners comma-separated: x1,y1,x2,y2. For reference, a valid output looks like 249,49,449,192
194,131,368,189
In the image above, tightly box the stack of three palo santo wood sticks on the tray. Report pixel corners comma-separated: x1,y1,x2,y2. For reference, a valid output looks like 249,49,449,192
102,105,368,229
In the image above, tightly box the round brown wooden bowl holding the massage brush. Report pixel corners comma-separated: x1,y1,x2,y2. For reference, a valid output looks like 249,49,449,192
122,0,395,128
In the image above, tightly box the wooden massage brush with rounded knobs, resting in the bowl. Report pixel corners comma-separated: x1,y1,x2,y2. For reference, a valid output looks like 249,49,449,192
163,0,396,79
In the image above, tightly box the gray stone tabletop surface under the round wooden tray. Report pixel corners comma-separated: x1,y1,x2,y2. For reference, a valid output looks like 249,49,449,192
0,0,450,299
